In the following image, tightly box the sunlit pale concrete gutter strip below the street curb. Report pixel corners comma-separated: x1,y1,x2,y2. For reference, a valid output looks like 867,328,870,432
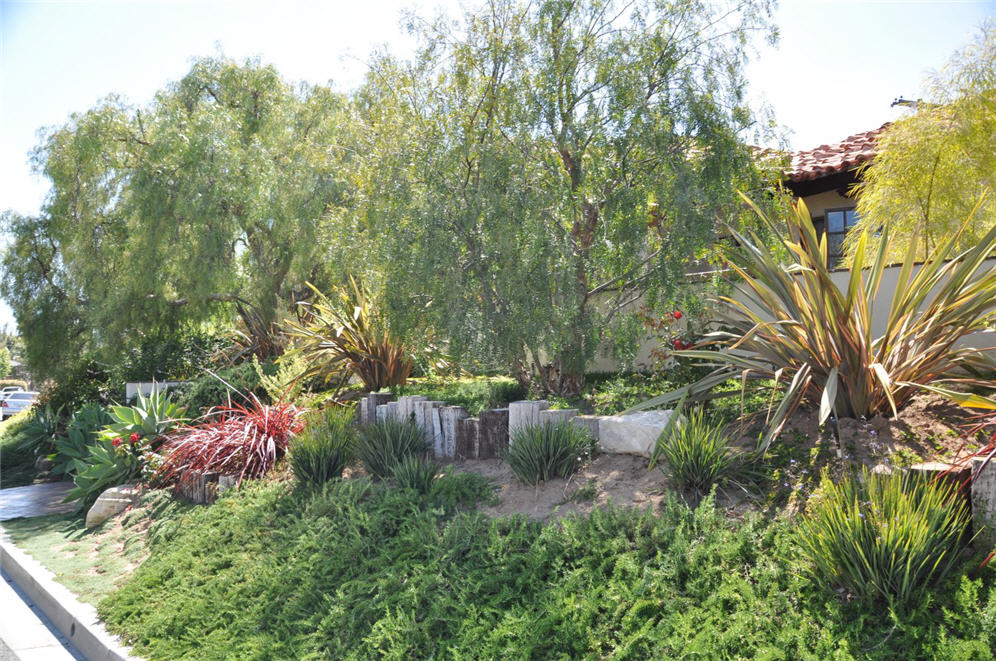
0,573,86,661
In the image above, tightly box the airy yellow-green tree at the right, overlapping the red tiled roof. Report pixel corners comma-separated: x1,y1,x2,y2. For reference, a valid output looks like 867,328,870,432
846,22,996,262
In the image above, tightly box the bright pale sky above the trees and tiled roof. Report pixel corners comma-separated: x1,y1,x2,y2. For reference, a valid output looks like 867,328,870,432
0,0,996,325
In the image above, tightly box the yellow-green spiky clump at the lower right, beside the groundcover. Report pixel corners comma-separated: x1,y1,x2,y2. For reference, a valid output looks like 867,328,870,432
798,470,968,610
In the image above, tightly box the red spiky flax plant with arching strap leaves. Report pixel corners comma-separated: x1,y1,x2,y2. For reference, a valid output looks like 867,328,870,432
152,397,304,486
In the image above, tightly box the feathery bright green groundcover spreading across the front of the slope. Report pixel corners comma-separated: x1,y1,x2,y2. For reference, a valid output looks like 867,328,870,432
99,475,996,660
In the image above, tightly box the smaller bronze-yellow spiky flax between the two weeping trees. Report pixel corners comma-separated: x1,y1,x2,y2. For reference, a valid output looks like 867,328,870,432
287,278,412,390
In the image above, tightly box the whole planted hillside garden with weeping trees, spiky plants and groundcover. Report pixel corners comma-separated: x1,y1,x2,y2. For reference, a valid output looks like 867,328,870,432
0,1,996,659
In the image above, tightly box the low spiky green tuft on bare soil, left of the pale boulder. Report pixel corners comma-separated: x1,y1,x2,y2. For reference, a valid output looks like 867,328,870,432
505,422,595,484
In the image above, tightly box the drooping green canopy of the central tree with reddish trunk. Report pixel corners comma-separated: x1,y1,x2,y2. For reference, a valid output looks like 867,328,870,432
333,0,784,395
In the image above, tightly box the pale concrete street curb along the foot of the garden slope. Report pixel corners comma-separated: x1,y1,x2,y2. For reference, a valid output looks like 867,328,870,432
0,526,139,661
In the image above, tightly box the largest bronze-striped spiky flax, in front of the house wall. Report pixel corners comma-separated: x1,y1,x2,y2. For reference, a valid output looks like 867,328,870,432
631,192,996,448
